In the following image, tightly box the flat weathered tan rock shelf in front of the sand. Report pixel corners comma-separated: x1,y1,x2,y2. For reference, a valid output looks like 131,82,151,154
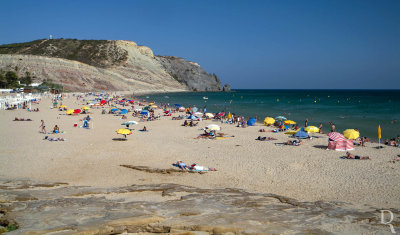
0,179,400,235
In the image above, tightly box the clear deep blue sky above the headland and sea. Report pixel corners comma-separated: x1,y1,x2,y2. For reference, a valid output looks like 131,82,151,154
0,0,400,89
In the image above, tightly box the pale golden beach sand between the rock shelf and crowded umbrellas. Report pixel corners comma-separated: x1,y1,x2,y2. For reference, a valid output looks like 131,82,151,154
0,95,400,208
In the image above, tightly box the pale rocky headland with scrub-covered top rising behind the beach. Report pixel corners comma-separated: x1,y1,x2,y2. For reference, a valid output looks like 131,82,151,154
0,39,228,92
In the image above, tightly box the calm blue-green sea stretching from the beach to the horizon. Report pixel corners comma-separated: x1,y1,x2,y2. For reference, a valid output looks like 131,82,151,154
138,90,400,140
